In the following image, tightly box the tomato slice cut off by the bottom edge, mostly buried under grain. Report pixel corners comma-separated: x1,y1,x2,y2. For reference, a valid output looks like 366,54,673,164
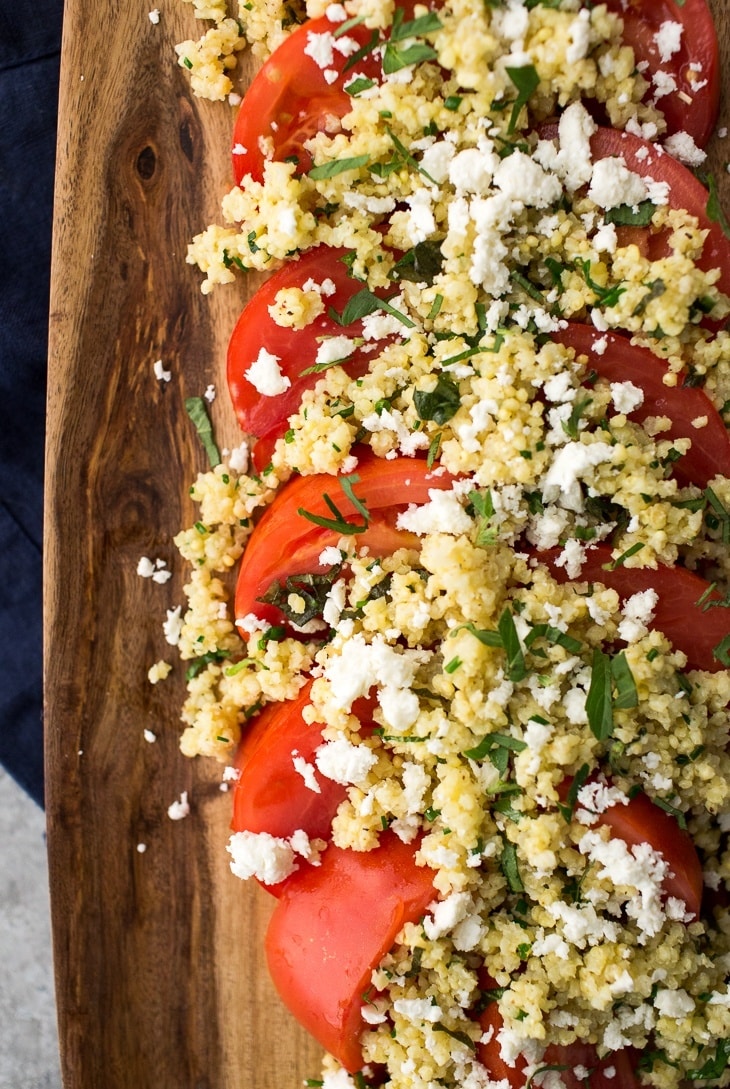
476,1002,640,1089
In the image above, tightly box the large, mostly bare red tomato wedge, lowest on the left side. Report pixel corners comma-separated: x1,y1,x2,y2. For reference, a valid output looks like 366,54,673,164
266,832,435,1073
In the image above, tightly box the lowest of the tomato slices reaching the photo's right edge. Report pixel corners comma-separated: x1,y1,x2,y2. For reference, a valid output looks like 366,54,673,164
536,545,730,672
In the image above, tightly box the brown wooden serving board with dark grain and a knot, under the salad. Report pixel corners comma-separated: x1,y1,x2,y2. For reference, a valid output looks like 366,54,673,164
45,0,730,1089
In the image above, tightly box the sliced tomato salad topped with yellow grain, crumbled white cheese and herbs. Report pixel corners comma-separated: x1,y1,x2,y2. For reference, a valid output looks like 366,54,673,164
169,0,730,1089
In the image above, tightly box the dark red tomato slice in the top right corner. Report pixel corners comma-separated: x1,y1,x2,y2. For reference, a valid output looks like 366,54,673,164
606,0,720,147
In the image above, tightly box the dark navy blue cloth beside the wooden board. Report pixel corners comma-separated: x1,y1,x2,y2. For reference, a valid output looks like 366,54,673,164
0,0,63,805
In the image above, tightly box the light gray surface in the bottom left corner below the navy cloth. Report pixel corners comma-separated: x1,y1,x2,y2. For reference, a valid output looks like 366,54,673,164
0,768,61,1089
